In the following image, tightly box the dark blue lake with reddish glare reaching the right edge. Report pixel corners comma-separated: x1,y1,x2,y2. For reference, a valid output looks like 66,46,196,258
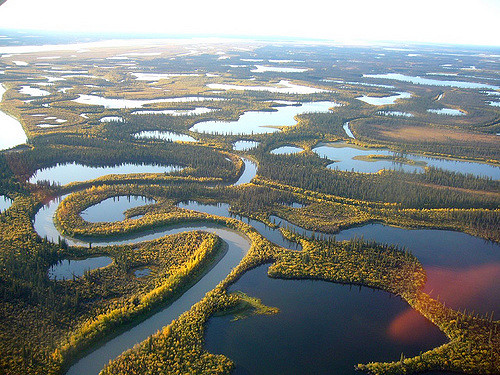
270,216,500,314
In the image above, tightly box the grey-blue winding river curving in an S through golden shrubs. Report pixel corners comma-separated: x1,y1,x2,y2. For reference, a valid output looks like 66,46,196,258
33,159,257,375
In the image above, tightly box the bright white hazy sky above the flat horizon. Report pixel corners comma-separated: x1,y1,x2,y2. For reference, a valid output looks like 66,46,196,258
0,0,500,46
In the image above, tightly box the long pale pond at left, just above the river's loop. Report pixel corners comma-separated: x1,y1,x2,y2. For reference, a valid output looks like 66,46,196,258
29,162,182,185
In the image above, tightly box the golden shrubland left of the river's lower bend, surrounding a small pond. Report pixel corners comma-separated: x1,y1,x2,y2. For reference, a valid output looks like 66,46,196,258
0,184,226,374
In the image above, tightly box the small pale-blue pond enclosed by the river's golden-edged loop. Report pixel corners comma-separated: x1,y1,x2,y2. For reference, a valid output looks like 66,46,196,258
81,195,156,223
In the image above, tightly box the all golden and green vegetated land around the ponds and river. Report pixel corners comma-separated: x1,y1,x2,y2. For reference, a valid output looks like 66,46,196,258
0,41,500,375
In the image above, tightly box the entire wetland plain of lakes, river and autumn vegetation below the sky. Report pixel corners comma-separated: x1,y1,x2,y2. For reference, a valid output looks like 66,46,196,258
0,36,500,375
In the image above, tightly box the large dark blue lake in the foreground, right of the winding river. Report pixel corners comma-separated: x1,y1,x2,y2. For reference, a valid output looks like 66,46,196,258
205,266,446,375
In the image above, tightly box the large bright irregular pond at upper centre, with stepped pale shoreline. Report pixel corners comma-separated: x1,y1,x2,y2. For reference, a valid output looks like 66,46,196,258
189,102,339,135
